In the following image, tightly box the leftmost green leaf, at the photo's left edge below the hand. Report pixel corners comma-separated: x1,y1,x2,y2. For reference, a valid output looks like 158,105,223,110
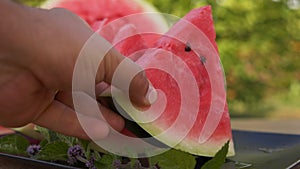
0,134,30,155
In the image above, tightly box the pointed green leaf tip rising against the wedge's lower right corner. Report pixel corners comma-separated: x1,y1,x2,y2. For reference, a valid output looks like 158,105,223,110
201,141,229,169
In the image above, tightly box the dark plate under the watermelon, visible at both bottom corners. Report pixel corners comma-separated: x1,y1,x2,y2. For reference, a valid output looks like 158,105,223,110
0,130,300,169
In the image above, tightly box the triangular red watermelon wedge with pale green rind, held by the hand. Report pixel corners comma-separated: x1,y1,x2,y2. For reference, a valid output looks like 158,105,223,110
113,6,234,156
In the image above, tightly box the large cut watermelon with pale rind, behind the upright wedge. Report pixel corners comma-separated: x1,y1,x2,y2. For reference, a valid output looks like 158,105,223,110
43,0,168,45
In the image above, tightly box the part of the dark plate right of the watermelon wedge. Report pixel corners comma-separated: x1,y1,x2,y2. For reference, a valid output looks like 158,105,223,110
230,130,300,169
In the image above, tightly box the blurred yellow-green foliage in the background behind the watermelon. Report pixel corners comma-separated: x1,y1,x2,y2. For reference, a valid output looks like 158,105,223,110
19,0,300,116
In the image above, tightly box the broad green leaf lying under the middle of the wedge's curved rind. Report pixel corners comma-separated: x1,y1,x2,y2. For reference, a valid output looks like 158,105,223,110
150,149,196,169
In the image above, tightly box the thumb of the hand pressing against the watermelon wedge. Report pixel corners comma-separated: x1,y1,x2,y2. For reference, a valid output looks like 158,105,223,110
76,34,156,107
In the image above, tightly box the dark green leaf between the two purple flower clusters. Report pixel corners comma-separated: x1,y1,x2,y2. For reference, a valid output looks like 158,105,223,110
37,141,69,161
